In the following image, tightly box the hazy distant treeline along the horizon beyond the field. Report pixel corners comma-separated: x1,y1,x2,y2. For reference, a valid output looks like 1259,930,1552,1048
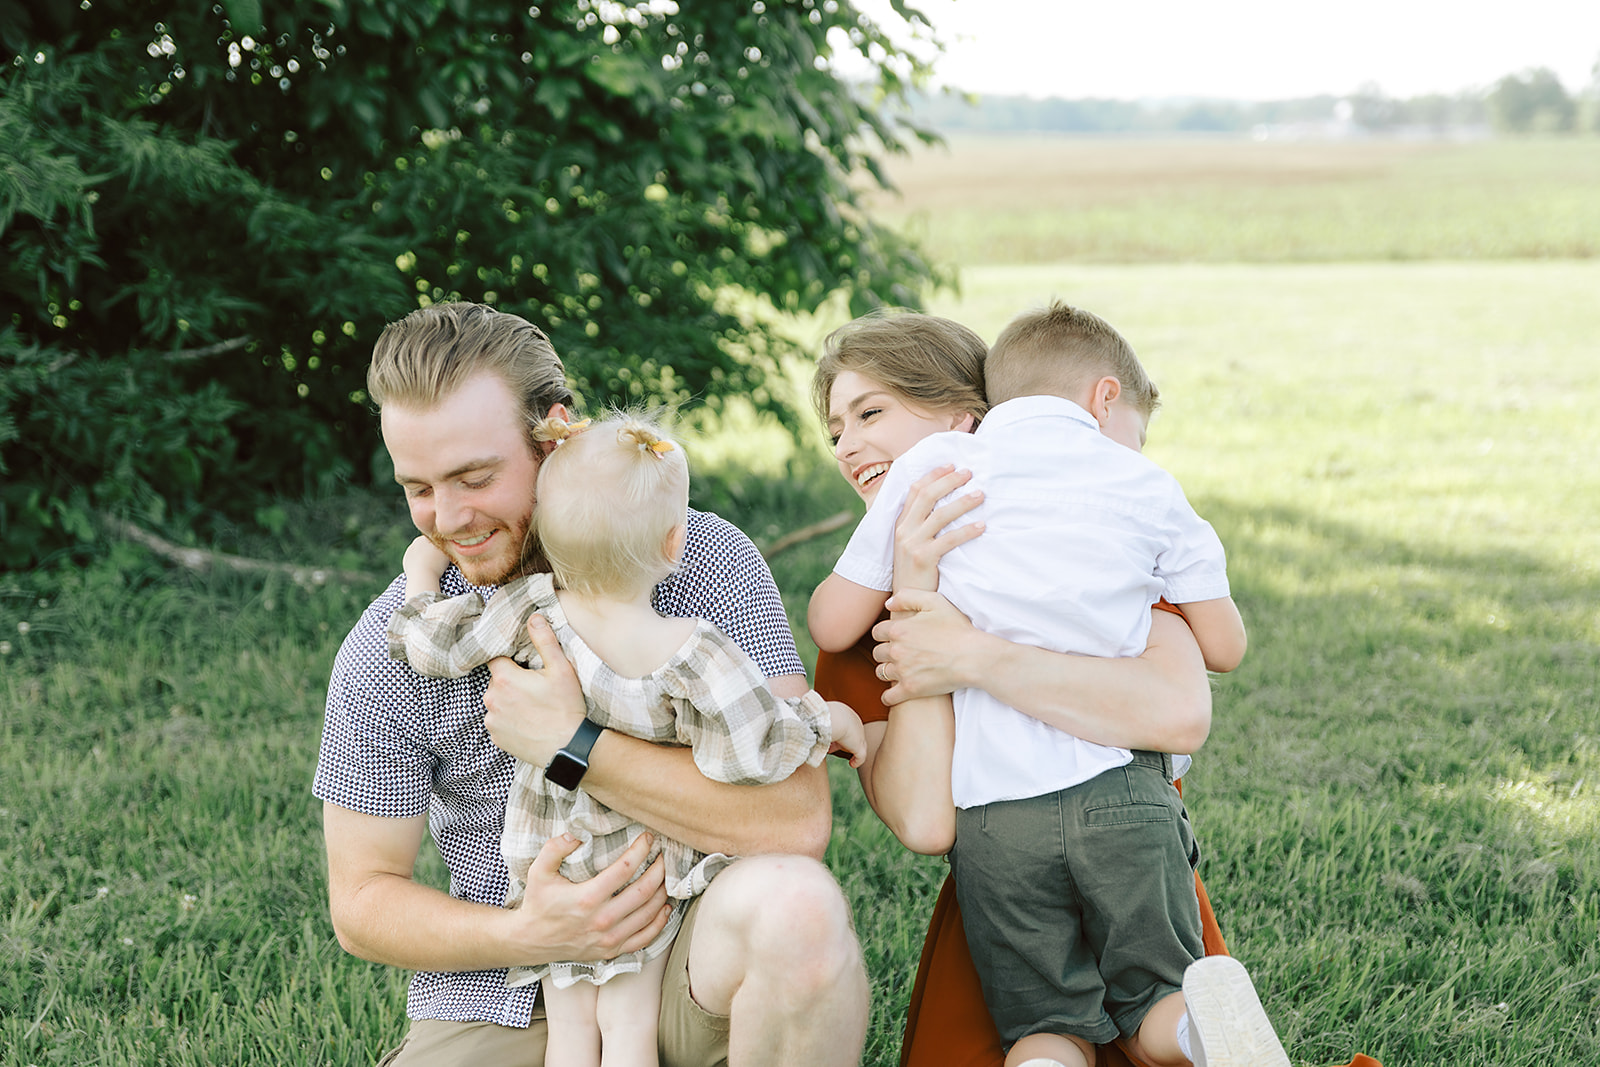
912,64,1600,134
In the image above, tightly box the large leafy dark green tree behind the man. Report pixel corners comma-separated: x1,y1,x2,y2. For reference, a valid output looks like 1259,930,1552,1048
0,0,938,566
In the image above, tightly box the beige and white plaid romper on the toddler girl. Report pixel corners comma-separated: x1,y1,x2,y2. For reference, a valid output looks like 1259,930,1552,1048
389,574,832,989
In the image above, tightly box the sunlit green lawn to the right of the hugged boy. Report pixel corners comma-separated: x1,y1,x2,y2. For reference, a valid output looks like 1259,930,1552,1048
774,262,1600,1064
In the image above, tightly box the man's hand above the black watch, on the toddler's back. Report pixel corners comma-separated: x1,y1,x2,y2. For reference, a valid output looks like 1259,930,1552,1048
483,614,584,767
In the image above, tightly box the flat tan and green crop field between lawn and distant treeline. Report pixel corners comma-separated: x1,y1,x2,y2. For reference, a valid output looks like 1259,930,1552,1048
877,136,1600,266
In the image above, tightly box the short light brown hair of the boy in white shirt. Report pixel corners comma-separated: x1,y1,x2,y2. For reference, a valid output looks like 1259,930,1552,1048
984,301,1162,419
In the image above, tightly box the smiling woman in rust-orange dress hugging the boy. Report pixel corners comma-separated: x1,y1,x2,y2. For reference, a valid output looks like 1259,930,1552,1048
814,314,1374,1067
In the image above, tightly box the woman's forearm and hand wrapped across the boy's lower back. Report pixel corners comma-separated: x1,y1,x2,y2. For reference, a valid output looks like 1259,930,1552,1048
872,590,1211,752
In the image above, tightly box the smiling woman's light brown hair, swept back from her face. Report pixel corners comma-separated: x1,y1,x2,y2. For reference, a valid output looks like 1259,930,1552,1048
811,309,989,424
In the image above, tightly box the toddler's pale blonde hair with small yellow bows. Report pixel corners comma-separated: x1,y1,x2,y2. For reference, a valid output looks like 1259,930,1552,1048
533,413,690,597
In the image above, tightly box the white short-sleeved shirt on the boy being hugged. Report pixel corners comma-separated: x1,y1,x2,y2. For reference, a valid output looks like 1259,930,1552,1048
834,397,1229,808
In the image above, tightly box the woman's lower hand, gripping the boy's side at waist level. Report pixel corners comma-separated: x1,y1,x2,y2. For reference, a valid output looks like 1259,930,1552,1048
872,589,989,707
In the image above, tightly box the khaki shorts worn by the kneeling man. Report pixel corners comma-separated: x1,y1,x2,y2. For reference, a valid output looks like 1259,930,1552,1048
378,897,728,1067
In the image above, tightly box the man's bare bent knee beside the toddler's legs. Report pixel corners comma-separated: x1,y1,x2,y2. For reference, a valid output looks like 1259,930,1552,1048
661,856,867,1067
